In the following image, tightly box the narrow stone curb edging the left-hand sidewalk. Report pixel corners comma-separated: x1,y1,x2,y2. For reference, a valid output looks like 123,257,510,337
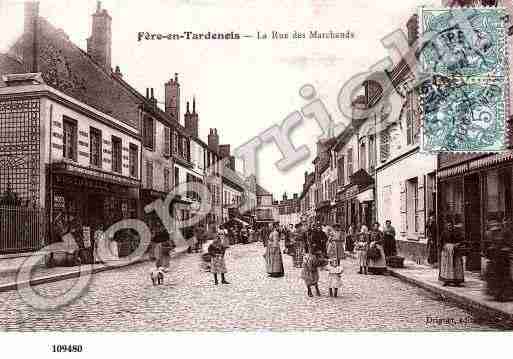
0,248,188,293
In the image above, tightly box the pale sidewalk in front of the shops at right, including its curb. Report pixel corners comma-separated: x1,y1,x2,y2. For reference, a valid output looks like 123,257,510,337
388,261,513,325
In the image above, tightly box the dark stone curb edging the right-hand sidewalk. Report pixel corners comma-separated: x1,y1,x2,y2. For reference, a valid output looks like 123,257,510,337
388,268,513,328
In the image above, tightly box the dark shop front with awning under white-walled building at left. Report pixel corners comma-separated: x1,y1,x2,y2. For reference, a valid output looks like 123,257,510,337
48,162,140,256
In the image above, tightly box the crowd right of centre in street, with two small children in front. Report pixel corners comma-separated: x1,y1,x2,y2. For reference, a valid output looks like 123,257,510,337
262,221,396,297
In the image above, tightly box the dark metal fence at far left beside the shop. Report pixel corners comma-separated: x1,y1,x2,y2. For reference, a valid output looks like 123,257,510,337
0,207,47,254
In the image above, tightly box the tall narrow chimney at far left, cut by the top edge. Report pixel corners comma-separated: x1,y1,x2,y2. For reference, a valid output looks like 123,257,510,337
22,1,39,73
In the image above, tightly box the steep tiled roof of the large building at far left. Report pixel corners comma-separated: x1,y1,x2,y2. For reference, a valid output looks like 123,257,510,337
0,17,192,136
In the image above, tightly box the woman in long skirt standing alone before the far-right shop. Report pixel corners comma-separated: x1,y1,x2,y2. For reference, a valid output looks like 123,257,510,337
438,221,465,286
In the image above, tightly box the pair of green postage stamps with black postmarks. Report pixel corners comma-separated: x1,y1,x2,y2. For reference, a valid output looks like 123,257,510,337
418,8,509,152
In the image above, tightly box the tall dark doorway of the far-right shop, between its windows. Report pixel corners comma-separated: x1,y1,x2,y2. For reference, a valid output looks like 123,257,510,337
464,174,481,271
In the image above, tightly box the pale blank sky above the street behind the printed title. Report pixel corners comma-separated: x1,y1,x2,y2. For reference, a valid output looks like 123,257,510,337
0,0,437,199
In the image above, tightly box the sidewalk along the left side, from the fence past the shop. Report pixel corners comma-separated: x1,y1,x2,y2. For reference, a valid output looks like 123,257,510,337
0,247,188,293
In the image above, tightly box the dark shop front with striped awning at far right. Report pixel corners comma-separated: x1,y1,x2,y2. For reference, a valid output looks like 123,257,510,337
438,152,513,271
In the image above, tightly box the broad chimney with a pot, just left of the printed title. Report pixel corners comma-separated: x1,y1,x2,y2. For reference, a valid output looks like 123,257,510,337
87,1,112,71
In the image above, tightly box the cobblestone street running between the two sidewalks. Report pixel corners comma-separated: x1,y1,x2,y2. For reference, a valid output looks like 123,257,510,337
0,243,504,331
